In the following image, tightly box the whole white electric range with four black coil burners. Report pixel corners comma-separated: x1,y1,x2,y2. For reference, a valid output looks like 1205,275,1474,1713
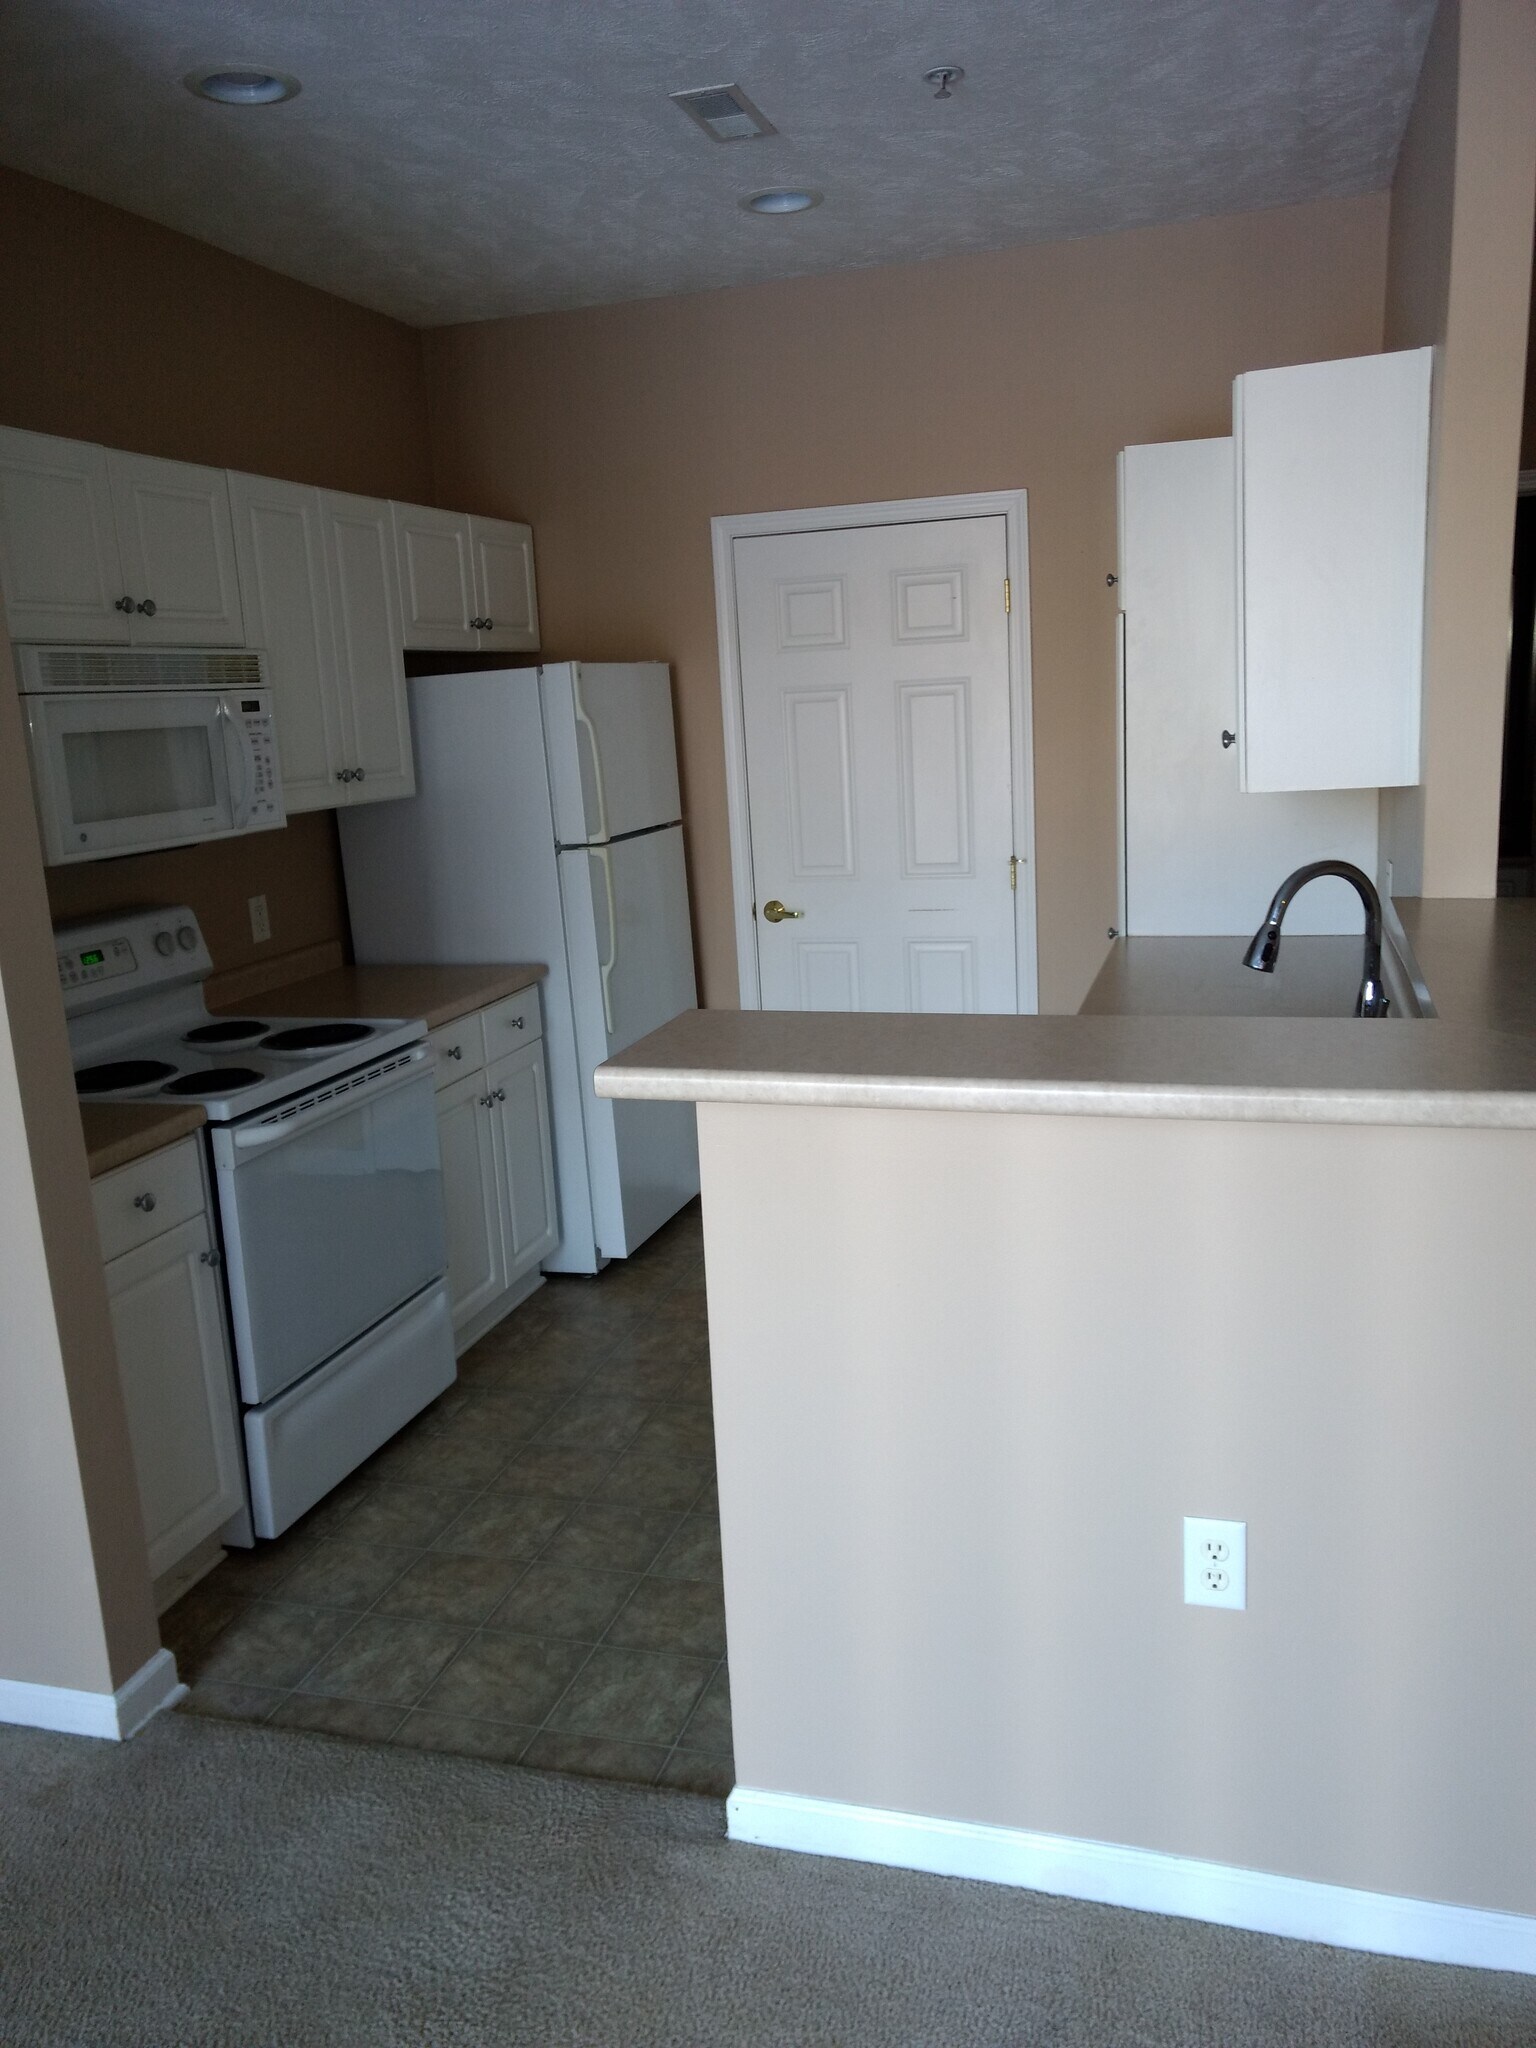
55,909,457,1542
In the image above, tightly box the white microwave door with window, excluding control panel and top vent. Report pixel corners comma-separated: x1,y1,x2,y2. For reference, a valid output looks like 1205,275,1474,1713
25,690,258,866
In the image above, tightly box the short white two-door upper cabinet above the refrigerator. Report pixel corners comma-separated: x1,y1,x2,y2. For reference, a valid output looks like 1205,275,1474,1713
389,504,539,653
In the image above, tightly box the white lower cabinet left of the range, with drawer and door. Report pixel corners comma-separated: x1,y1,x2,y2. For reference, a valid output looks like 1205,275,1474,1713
92,1139,246,1579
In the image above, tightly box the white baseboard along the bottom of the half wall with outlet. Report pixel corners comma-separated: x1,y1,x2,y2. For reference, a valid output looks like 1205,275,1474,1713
725,1786,1536,1974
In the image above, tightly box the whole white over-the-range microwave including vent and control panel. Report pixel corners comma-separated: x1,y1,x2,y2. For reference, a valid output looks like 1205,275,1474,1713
16,647,285,866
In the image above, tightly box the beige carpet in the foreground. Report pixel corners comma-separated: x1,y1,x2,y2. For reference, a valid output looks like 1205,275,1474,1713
0,1714,1536,2048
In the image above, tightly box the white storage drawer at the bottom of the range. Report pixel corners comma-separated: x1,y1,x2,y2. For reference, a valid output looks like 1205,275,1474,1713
246,1282,457,1536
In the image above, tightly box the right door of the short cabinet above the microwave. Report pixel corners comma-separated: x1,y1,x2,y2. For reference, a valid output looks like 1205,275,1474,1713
106,449,246,647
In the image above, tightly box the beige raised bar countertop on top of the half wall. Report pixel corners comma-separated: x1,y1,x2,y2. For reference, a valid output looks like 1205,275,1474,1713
596,901,1536,1128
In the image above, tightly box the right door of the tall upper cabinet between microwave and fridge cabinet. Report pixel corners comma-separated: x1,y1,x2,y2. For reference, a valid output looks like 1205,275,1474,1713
319,492,416,803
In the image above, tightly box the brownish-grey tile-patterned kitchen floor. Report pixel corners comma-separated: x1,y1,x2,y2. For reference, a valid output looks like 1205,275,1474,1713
162,1204,733,1792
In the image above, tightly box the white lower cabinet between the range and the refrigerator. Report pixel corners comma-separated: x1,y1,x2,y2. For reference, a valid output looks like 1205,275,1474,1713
432,989,559,1352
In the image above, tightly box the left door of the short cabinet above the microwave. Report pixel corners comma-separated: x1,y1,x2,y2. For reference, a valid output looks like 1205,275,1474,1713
0,426,129,641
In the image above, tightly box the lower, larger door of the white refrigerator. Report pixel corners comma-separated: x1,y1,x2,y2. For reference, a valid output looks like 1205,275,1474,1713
559,825,698,1257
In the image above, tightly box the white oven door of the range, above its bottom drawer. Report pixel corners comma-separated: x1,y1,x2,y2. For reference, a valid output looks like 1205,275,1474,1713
213,1044,449,1405
